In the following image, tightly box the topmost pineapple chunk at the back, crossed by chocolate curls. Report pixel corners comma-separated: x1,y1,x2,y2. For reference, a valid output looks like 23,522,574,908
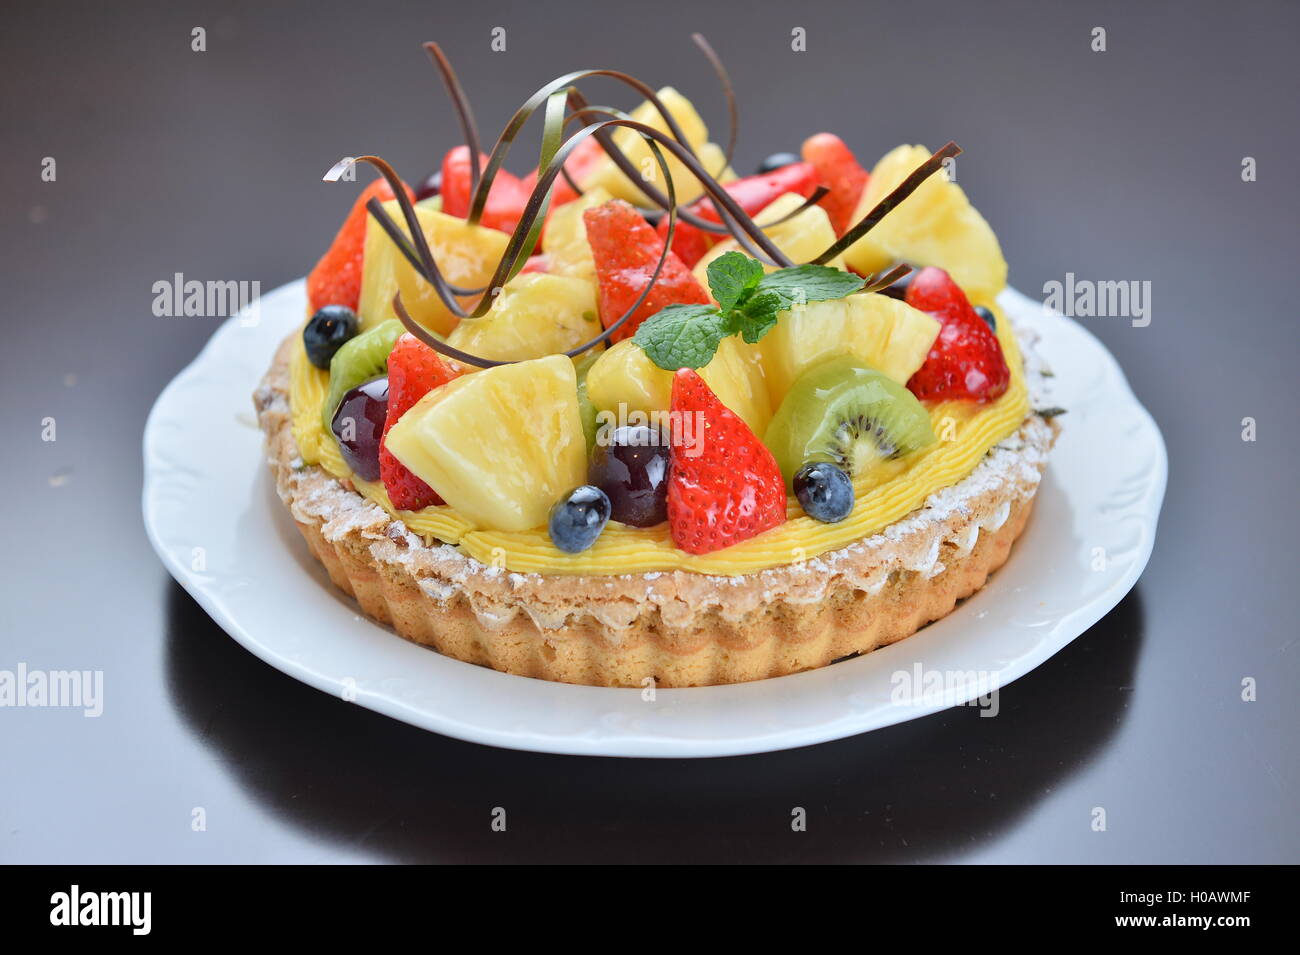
579,86,736,205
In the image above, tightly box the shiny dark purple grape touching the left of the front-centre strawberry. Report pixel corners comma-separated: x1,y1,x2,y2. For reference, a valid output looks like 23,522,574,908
586,425,668,528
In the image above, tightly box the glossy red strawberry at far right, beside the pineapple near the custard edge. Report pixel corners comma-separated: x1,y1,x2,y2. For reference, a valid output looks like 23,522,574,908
905,266,1011,401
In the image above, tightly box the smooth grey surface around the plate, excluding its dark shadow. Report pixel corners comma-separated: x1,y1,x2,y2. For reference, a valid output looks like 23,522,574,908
0,0,1300,861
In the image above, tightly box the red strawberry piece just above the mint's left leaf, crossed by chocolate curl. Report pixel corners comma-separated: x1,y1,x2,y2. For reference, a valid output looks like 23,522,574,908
582,199,710,342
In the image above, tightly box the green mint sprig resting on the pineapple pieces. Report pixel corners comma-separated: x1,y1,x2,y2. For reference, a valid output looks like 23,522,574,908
632,252,866,372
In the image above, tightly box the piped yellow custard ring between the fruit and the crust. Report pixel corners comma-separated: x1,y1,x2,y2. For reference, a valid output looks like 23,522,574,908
289,307,1030,576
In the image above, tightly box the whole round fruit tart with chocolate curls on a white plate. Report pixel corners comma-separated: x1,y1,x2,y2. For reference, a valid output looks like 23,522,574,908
255,36,1057,686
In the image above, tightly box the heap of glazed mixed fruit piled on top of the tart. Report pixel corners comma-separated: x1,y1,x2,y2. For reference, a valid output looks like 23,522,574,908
303,44,1010,554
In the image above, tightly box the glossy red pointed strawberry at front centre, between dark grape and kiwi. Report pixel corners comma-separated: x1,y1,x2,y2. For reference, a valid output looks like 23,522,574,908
668,368,785,554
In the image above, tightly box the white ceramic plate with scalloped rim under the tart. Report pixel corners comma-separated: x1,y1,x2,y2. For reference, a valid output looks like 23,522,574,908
143,282,1166,756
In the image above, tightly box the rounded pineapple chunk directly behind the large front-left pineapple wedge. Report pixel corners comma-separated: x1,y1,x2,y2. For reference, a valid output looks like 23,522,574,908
447,272,601,361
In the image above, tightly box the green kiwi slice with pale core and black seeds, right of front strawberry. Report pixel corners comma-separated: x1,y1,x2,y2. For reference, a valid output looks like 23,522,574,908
763,355,935,489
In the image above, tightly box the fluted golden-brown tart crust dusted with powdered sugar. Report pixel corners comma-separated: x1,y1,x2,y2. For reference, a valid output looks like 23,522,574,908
254,333,1057,687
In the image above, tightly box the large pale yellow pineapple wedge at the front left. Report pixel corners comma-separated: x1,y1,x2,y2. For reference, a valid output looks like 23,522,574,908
385,355,586,530
